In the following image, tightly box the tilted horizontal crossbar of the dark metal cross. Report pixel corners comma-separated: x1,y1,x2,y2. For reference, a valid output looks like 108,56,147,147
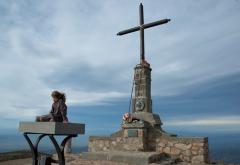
117,19,170,36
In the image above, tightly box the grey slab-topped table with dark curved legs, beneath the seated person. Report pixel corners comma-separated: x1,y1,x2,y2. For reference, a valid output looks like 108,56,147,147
19,122,85,165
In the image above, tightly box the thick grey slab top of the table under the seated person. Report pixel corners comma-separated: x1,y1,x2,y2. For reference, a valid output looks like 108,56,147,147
19,122,85,135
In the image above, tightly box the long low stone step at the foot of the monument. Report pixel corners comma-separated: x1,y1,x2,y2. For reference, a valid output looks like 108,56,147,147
82,151,166,165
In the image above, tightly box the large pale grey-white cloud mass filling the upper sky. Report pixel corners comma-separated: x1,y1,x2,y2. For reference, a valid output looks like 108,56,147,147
0,0,240,120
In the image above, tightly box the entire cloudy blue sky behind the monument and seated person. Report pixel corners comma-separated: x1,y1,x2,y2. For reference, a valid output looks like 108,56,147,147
0,0,240,137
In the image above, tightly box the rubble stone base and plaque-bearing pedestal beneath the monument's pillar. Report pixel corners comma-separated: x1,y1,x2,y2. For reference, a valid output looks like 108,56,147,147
84,121,209,163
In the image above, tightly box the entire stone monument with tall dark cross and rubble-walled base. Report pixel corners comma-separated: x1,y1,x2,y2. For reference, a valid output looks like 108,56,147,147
83,4,209,165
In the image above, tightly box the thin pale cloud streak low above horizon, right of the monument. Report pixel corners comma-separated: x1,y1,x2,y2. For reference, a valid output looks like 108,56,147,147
163,115,240,133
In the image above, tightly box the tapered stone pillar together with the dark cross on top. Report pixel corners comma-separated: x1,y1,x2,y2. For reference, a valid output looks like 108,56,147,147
117,3,170,127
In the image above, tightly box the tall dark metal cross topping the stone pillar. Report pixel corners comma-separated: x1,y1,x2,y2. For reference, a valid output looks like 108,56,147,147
117,3,170,63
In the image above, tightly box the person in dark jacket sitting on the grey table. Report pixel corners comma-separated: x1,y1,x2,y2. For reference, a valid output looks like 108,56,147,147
36,91,68,123
